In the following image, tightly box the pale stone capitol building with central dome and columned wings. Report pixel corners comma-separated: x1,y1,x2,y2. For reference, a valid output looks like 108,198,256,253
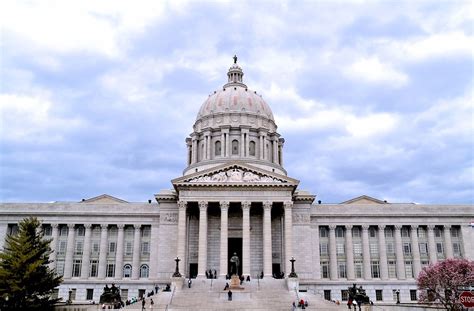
0,58,474,304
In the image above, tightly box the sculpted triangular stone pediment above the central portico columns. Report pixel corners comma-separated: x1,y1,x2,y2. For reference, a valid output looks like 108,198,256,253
172,163,299,186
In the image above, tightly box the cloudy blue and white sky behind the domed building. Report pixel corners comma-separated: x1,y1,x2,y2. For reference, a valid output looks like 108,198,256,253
0,0,474,204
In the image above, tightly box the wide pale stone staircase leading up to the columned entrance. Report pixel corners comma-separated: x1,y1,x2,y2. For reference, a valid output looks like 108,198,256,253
125,279,344,311
